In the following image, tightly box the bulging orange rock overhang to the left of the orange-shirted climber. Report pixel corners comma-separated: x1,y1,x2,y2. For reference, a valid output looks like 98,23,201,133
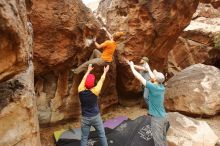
30,0,105,74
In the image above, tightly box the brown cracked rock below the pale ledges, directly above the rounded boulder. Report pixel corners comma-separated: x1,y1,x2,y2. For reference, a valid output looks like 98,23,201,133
168,37,220,77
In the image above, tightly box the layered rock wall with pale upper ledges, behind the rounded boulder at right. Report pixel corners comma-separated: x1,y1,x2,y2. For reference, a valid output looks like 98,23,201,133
168,4,220,76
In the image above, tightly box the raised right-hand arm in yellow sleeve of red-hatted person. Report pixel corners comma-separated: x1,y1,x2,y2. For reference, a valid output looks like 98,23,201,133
91,65,109,96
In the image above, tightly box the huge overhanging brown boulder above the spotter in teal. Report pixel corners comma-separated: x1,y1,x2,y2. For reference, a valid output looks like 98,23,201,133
97,0,199,104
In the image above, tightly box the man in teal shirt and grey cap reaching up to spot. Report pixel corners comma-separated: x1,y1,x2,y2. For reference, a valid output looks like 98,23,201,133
128,61,169,146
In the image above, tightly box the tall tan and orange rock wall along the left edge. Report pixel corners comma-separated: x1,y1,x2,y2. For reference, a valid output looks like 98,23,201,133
0,0,41,146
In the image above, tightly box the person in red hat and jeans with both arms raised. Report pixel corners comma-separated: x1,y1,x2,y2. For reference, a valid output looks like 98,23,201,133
78,64,109,146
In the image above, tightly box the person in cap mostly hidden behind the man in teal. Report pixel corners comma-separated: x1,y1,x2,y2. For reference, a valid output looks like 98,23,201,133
124,57,151,106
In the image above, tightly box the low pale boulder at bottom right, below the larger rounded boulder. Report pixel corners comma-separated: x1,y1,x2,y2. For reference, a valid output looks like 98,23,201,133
167,113,218,146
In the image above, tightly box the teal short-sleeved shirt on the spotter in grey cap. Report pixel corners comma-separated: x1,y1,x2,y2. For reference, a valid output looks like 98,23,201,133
146,81,166,117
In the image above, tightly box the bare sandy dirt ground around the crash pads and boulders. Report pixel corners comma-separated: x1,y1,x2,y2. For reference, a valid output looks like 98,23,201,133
40,105,220,146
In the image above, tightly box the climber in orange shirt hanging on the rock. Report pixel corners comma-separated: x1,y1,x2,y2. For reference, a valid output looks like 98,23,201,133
72,32,124,74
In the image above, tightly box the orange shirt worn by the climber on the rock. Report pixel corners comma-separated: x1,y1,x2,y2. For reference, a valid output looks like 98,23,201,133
101,40,116,62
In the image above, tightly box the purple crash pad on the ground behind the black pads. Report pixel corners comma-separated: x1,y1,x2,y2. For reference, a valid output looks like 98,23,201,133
104,116,128,129
